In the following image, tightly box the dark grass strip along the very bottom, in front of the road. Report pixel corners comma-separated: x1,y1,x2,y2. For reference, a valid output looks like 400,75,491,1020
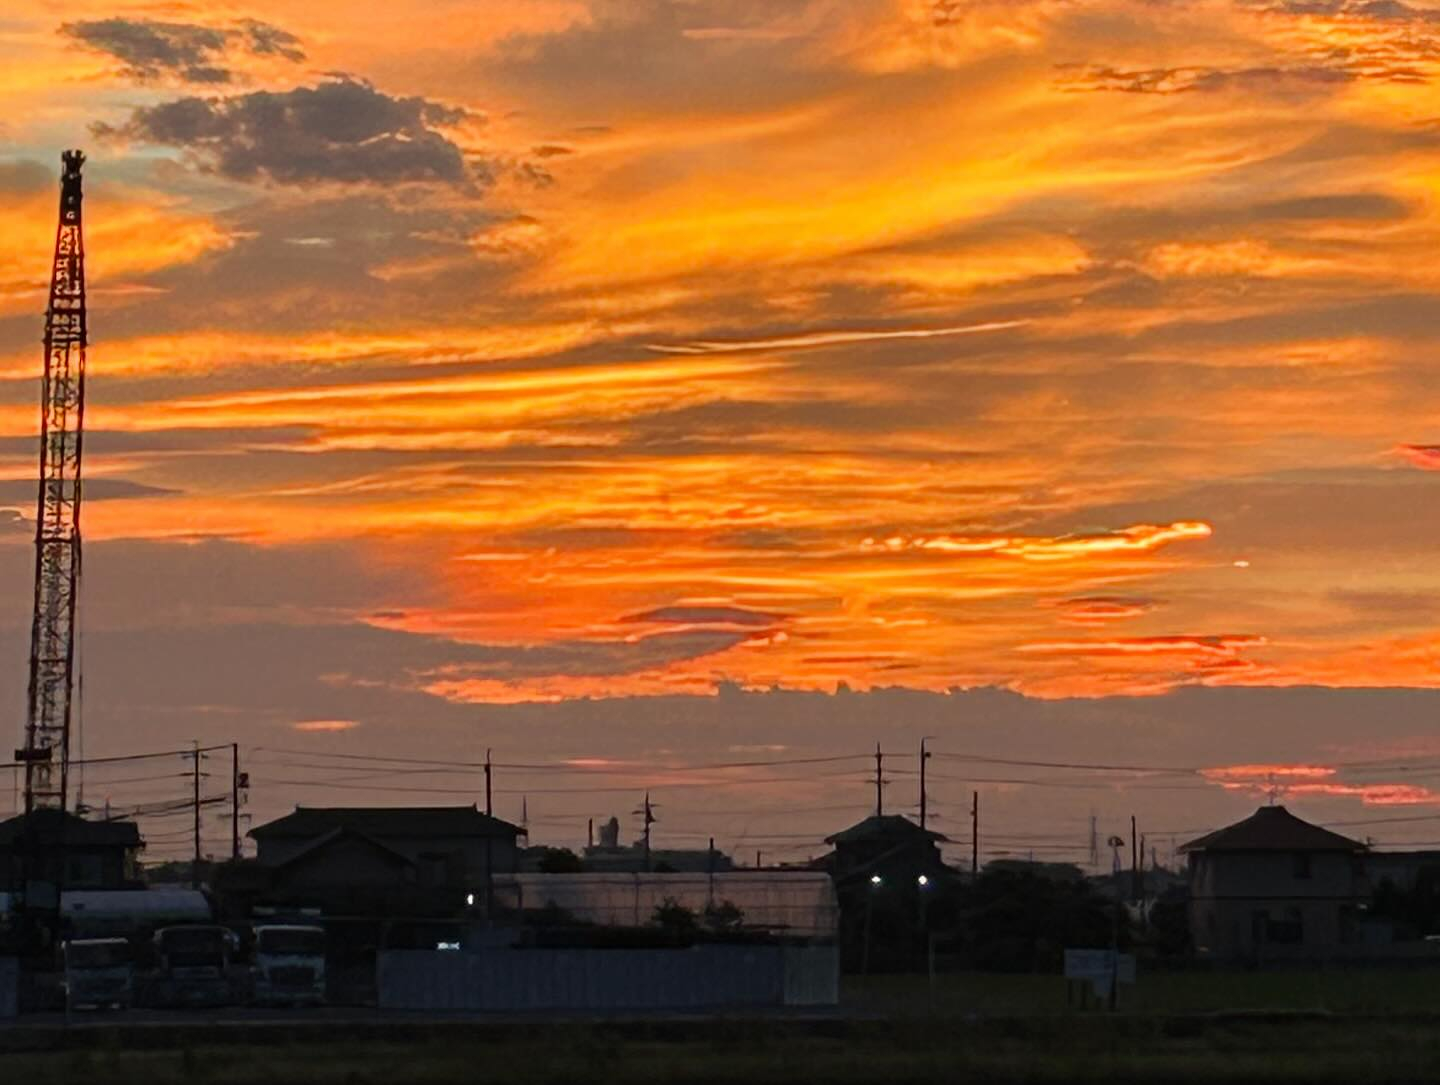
3,1017,1440,1085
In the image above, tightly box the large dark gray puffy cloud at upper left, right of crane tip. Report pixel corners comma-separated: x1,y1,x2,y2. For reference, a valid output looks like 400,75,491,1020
94,75,488,186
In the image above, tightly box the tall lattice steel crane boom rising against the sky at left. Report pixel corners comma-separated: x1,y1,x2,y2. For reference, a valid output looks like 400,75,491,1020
16,151,85,813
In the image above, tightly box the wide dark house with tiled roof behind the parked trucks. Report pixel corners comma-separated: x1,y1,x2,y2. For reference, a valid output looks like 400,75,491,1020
236,805,520,916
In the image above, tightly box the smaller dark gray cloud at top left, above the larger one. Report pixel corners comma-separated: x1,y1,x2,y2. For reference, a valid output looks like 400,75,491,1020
59,17,305,84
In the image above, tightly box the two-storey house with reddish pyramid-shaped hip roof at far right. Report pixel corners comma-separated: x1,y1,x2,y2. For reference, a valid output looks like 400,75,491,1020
1181,807,1367,963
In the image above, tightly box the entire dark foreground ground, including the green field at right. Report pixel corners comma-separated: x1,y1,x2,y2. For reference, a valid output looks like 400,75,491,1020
8,970,1440,1085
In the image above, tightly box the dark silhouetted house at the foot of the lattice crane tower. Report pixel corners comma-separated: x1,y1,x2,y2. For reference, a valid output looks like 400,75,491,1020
0,810,144,906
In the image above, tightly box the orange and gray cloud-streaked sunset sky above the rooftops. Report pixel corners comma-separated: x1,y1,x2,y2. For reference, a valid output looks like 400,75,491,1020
0,0,1440,854
